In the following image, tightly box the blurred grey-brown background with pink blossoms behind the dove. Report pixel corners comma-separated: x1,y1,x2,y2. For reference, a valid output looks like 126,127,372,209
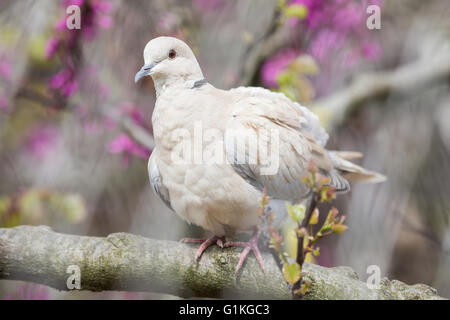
0,0,450,299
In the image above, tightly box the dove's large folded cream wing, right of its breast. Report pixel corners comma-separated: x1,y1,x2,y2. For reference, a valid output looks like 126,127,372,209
225,88,348,200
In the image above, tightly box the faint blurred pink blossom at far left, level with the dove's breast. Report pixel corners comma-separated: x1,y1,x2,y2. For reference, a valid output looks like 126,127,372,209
25,126,59,159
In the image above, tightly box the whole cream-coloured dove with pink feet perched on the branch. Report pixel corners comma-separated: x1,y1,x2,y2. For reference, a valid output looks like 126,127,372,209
135,37,384,271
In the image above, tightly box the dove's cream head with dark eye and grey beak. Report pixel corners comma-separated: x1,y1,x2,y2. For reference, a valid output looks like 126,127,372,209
134,37,203,90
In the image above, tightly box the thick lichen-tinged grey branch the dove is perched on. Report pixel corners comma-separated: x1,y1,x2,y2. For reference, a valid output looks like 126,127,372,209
0,226,440,299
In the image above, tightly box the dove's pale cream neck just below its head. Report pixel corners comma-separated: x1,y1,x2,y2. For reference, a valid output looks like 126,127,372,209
153,64,204,98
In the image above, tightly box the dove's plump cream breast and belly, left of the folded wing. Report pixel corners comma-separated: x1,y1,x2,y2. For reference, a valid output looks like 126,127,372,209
152,85,261,236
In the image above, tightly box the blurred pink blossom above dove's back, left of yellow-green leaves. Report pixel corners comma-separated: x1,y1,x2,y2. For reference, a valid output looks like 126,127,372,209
261,49,299,88
